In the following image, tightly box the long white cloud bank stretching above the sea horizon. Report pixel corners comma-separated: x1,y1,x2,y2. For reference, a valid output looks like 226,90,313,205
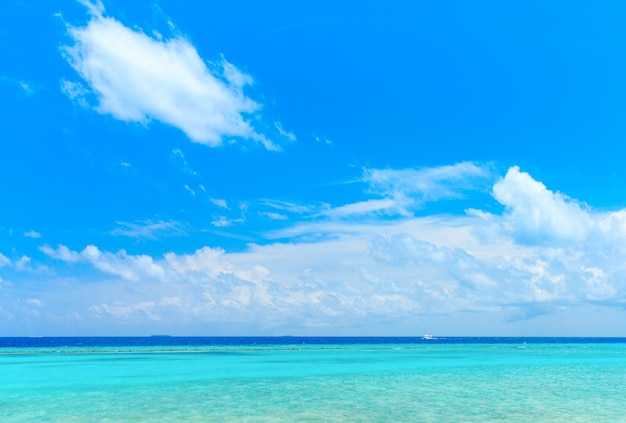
0,165,626,333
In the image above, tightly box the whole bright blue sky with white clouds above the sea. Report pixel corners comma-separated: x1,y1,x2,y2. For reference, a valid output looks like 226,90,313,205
0,0,626,336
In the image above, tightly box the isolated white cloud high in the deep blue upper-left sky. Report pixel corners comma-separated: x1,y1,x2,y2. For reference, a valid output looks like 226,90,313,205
61,1,286,150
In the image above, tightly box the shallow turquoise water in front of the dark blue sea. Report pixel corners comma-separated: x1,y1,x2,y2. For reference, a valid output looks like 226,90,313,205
0,343,626,422
